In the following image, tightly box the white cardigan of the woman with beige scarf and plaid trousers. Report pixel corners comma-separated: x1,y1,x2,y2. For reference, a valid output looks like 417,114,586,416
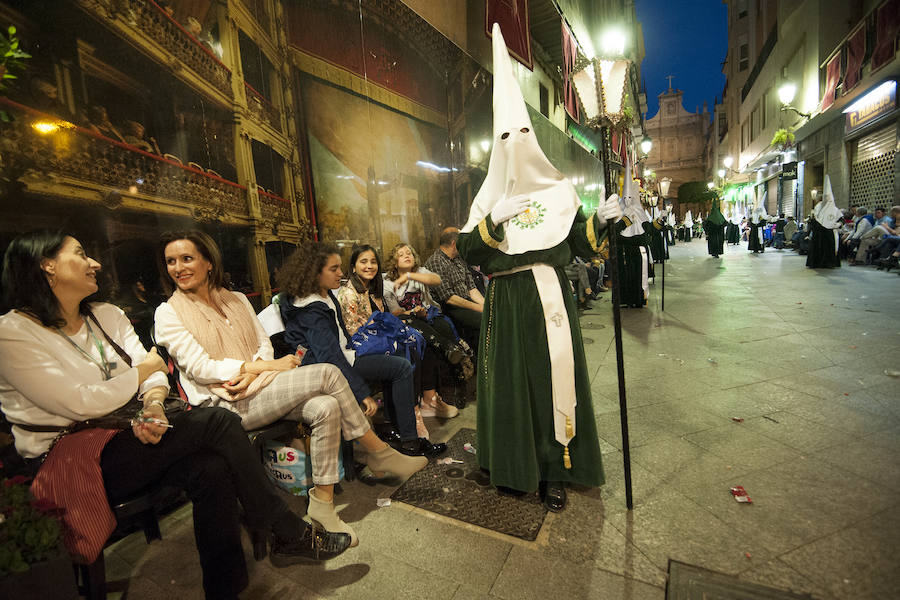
154,292,275,406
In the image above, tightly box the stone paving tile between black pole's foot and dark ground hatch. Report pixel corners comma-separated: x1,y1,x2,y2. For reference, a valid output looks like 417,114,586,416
607,490,774,575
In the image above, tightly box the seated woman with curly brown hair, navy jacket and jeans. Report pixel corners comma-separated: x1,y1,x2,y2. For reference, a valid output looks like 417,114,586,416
278,242,447,456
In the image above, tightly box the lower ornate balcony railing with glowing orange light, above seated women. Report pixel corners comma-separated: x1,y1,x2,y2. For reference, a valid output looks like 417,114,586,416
0,98,249,221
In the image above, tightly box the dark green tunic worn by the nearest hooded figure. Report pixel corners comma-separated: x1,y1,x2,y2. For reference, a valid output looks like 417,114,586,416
457,211,606,492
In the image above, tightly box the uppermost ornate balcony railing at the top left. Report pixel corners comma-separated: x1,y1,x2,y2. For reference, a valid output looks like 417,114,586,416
79,0,232,98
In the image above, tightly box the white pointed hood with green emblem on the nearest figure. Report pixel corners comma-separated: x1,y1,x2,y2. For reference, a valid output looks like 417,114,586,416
461,23,581,254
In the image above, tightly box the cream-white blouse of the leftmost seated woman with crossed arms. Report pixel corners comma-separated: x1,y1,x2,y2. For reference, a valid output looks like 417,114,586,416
0,303,169,458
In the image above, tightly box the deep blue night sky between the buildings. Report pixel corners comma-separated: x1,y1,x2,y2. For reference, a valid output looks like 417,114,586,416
635,0,728,119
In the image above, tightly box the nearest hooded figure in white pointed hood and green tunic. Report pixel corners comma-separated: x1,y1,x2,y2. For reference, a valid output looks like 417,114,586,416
457,24,631,511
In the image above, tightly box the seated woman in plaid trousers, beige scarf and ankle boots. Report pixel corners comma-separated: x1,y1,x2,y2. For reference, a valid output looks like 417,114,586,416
156,230,428,546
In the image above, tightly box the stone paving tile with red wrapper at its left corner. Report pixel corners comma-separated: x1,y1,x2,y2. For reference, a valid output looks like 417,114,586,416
706,456,896,554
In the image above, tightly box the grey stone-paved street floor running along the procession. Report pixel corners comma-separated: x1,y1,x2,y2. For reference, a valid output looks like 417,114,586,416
106,240,900,600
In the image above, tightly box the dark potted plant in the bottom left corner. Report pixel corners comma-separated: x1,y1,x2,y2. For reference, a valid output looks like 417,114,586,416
0,475,78,600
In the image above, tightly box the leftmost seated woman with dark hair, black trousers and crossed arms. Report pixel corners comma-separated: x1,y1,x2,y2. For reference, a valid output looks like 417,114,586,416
0,232,350,598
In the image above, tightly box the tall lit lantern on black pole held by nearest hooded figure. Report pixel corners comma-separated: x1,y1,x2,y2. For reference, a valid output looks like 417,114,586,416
572,25,636,510
